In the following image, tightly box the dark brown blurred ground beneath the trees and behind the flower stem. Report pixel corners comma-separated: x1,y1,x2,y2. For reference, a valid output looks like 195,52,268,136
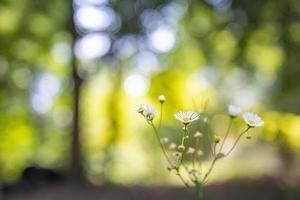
2,178,300,200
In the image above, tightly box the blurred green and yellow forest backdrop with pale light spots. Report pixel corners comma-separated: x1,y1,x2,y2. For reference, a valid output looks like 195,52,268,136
0,0,300,198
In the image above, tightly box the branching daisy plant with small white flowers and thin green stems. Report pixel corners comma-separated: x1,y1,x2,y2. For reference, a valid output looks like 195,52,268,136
137,101,264,200
